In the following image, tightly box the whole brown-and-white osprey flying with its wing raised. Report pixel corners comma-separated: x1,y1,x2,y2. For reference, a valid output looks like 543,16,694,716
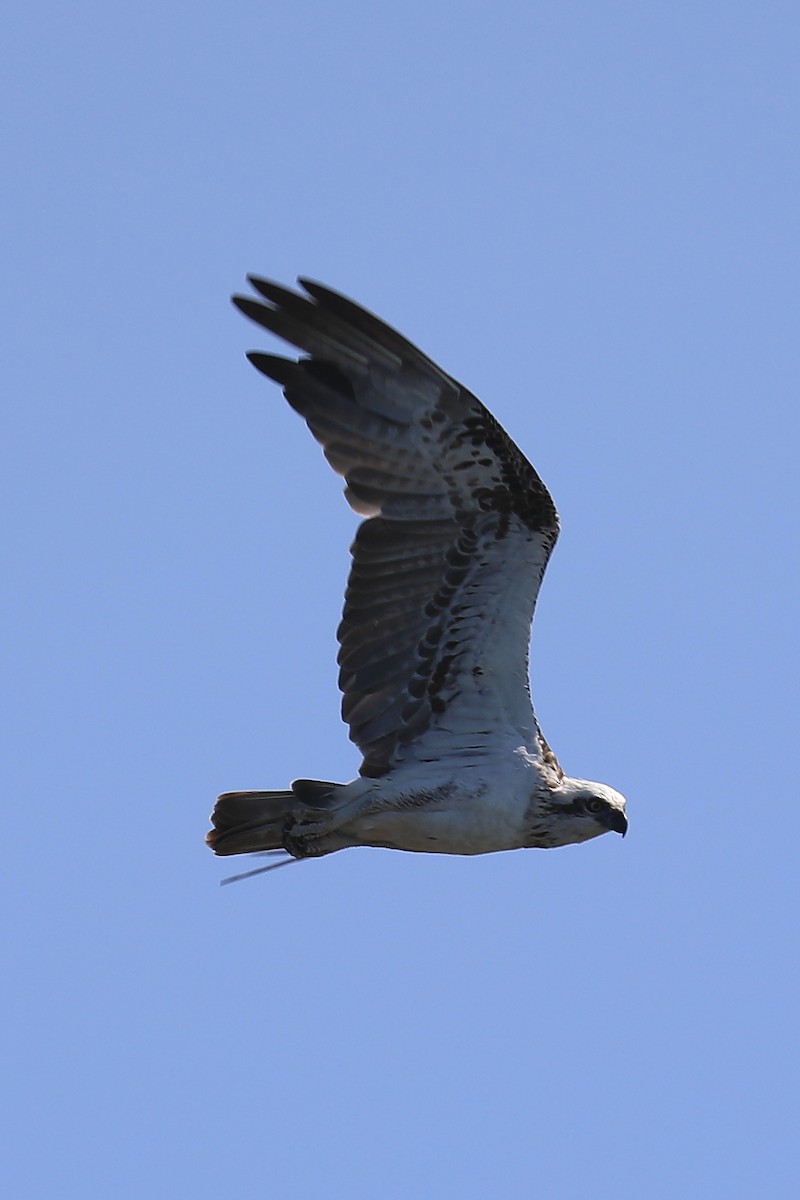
206,277,627,858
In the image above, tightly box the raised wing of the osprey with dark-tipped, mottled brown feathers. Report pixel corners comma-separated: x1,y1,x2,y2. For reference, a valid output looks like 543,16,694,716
234,276,559,776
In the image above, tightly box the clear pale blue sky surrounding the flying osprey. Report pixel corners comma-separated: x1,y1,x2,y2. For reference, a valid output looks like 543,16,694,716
0,0,800,1200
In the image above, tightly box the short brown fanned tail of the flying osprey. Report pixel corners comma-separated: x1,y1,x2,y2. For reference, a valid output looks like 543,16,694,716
205,779,342,854
